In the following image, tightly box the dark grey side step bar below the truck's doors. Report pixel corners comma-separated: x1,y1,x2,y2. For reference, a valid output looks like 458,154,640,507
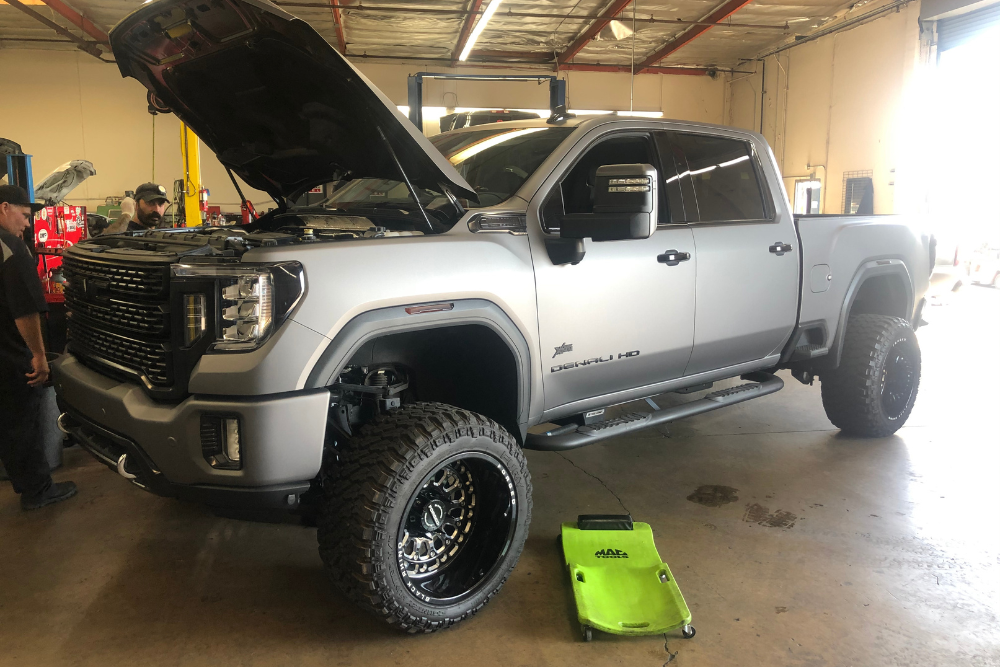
524,373,785,452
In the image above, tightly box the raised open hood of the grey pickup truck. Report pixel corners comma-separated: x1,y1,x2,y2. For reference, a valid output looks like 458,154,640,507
111,0,477,199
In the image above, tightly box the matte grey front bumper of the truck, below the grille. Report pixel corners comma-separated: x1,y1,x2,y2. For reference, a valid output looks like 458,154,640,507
52,355,330,507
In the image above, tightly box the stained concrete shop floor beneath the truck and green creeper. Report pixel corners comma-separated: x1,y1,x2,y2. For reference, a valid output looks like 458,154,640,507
0,286,1000,667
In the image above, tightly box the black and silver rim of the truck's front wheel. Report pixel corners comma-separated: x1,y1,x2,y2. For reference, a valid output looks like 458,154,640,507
396,452,517,605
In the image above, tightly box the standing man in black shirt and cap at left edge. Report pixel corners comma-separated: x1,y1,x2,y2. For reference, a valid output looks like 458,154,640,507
0,185,76,510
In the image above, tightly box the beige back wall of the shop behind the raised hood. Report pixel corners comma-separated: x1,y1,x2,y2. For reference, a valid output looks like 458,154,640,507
0,49,725,211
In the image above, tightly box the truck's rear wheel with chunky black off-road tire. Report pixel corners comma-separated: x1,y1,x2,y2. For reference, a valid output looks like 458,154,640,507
820,315,920,438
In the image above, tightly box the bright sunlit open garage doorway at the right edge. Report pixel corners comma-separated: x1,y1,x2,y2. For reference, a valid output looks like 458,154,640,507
896,3,1000,304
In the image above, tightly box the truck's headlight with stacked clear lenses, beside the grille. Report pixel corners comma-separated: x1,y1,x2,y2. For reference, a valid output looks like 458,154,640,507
170,262,305,352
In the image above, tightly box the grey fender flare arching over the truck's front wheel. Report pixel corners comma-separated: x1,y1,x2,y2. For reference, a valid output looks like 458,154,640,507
304,299,531,435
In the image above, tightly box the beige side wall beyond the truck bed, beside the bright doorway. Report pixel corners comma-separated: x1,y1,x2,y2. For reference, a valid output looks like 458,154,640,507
726,3,920,213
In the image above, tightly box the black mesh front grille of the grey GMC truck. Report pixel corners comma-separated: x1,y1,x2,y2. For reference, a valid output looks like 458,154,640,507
63,256,174,387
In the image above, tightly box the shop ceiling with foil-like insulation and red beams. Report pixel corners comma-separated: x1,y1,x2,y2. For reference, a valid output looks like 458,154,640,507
0,0,892,74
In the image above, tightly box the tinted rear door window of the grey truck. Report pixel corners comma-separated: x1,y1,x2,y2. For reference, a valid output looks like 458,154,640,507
672,132,767,222
